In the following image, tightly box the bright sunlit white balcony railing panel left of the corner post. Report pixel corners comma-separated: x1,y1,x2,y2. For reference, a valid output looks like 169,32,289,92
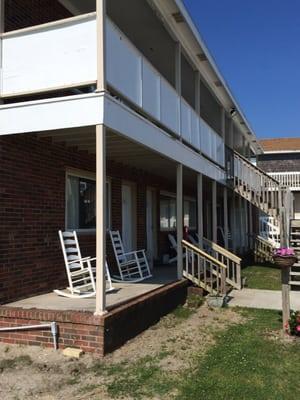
0,13,97,97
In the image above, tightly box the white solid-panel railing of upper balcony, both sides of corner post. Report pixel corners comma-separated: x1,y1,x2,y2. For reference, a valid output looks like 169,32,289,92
0,0,225,167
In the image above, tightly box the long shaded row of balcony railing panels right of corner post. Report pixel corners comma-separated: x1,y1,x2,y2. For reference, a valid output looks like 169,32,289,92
106,20,225,166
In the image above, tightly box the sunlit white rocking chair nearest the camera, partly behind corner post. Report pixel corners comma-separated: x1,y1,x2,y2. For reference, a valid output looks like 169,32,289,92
54,231,114,298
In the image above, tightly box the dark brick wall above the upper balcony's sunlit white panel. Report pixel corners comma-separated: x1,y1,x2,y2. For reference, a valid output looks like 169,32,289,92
5,0,72,32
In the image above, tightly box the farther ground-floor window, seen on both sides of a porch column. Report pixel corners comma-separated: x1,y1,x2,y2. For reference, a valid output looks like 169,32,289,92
160,194,196,231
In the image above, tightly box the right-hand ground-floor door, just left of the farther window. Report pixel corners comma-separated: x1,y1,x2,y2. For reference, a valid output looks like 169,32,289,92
146,188,157,268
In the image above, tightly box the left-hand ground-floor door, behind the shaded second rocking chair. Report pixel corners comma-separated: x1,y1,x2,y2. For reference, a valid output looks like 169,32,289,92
122,184,134,252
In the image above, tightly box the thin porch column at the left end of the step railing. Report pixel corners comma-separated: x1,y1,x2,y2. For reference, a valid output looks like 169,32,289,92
176,164,183,279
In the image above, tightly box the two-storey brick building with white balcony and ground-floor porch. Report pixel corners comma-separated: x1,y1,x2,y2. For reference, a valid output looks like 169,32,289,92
0,0,286,355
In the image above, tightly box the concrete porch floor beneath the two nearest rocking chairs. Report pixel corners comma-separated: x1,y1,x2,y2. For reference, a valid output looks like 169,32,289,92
5,266,177,312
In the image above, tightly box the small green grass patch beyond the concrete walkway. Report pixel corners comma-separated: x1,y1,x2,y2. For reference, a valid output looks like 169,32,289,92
242,264,281,290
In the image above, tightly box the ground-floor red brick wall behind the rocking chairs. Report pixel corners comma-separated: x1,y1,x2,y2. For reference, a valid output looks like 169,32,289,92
0,134,179,304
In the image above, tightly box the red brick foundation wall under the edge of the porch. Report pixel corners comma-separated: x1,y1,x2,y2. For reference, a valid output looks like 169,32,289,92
0,280,188,357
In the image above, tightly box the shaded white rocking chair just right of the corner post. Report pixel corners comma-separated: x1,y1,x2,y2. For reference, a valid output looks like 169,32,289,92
109,231,152,282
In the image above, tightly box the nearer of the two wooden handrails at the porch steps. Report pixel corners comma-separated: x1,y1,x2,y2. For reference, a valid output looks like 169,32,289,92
182,240,227,295
